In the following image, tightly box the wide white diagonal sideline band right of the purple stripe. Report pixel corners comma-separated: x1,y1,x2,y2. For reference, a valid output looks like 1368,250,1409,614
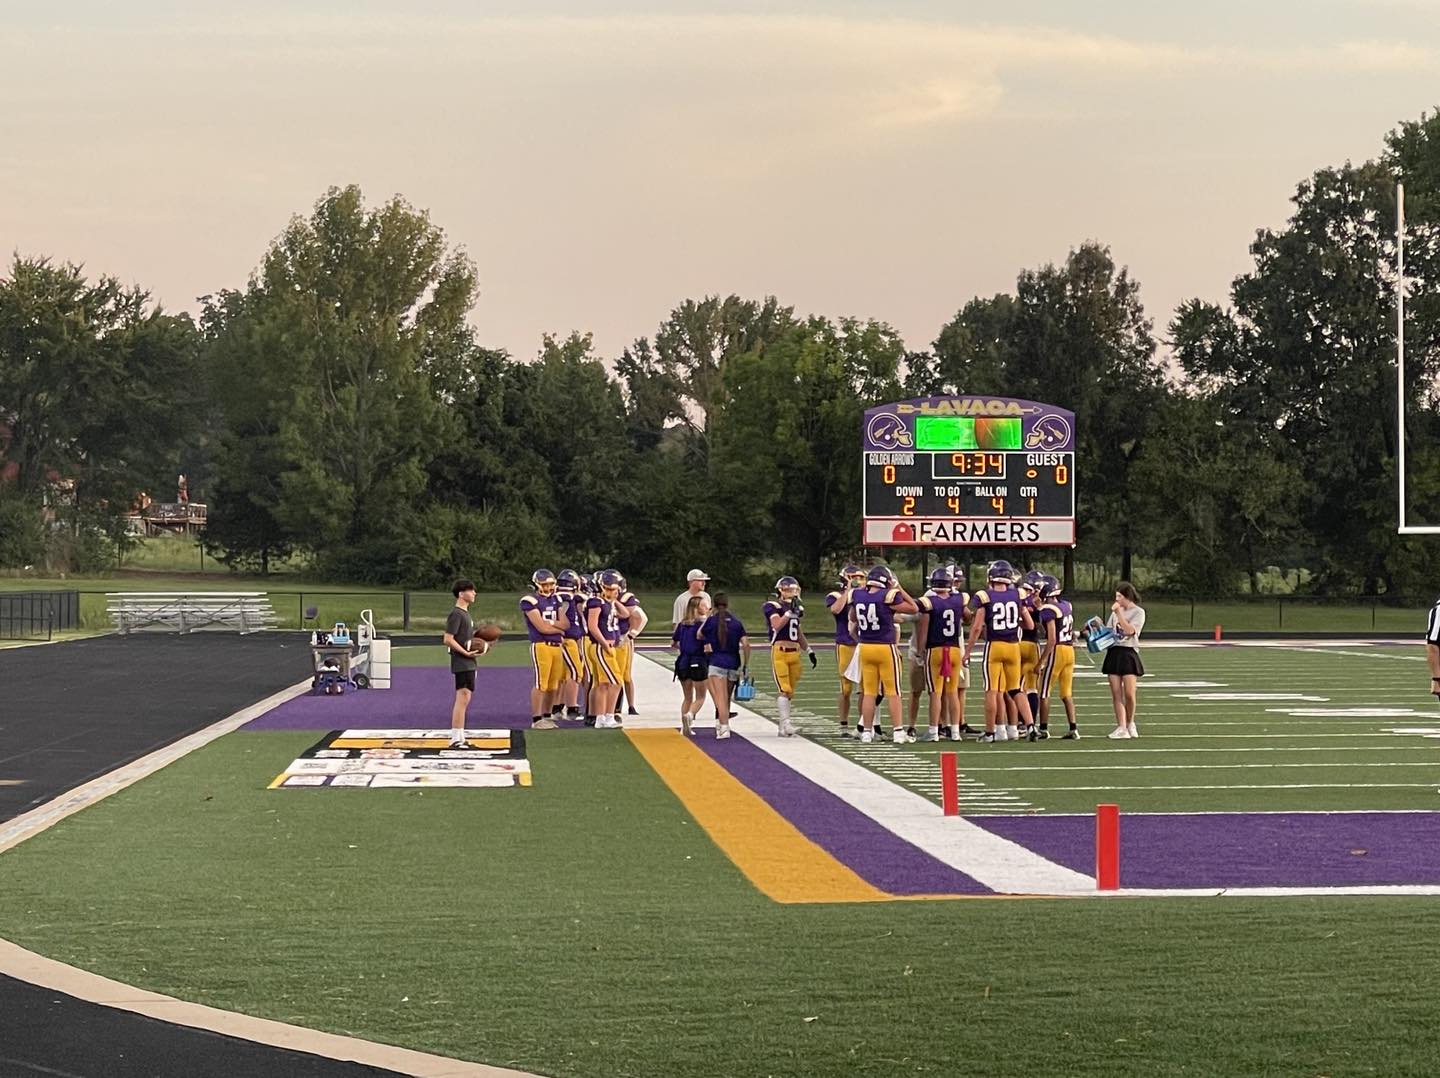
625,658,1096,895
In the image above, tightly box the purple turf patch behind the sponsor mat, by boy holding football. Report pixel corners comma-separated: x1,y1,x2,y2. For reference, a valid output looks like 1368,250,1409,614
240,666,534,730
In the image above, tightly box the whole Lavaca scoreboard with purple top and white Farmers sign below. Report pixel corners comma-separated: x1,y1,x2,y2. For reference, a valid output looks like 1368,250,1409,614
864,397,1076,547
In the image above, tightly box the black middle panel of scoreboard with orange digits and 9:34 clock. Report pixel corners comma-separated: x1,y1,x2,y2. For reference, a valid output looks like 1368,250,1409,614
864,449,1076,520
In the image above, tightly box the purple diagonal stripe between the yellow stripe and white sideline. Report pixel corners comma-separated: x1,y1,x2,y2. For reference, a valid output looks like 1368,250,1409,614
694,730,994,895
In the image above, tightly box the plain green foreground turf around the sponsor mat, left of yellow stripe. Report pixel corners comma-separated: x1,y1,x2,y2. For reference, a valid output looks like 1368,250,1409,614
8,719,1440,1077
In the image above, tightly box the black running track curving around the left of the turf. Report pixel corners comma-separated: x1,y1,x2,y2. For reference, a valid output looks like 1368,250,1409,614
0,633,417,1078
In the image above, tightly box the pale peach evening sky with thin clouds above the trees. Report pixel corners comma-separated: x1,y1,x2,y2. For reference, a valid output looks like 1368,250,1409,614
0,0,1440,357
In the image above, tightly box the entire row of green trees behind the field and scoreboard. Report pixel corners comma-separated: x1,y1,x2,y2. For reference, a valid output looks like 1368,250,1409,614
0,114,1440,597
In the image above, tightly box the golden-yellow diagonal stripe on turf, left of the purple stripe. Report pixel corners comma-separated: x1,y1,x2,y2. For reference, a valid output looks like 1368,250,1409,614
625,730,894,902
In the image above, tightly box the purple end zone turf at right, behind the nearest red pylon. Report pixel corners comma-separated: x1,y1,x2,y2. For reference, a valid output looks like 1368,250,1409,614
971,812,1440,888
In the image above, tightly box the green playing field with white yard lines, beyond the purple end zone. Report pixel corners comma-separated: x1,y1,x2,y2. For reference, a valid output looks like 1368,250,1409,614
752,643,1440,813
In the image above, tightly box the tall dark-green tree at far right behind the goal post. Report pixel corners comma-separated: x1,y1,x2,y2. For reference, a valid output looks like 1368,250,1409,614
1172,132,1440,594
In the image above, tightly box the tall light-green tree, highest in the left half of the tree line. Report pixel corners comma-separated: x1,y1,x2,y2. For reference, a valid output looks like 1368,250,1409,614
206,186,477,581
